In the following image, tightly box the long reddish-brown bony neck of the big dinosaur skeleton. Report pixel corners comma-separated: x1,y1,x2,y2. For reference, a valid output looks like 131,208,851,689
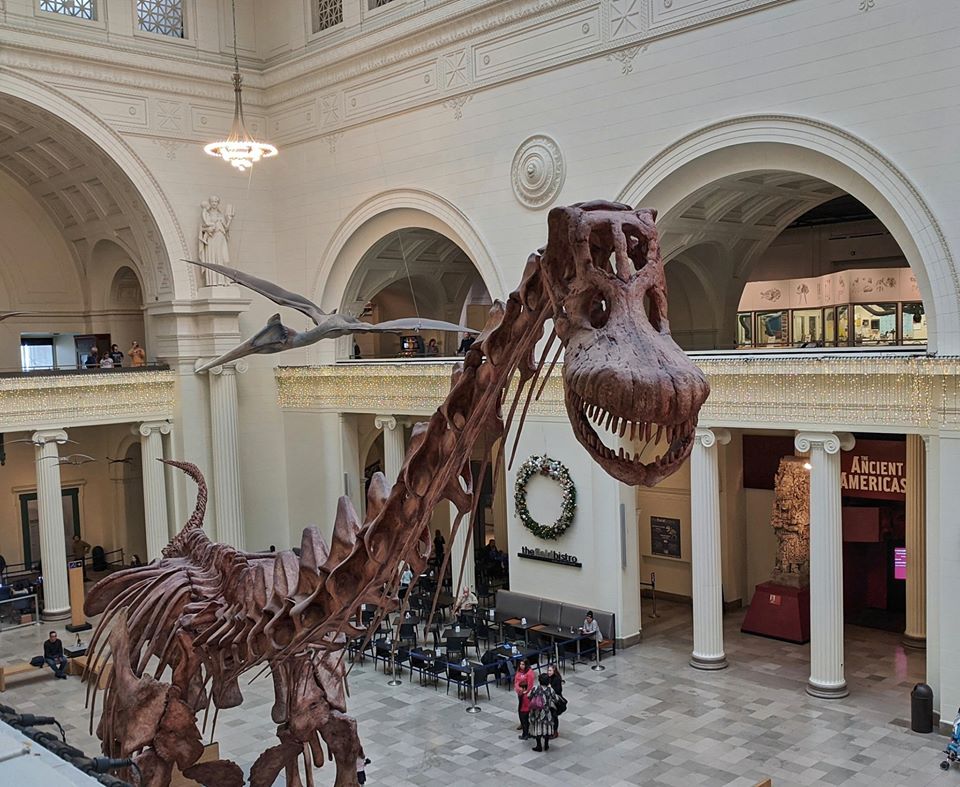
297,262,552,635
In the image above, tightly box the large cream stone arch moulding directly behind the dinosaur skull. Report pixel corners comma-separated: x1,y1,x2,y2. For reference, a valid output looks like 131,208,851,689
618,115,960,354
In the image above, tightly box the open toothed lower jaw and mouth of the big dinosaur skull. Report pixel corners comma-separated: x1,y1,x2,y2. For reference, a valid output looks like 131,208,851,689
566,387,697,486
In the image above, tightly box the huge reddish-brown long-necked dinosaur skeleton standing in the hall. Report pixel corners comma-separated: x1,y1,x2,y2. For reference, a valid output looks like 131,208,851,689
86,202,709,787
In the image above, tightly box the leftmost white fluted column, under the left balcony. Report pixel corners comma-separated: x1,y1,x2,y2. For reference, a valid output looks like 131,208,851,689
31,429,70,620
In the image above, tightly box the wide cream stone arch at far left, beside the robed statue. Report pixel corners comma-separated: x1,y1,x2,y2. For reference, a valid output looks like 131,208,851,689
0,67,196,301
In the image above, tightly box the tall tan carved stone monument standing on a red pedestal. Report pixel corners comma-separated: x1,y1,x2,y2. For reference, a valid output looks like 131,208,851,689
770,456,810,588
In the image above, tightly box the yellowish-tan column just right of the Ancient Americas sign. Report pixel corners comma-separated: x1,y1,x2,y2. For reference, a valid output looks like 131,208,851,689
903,434,927,648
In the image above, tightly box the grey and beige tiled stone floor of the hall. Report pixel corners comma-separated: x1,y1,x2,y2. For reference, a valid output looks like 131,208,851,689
0,605,960,787
